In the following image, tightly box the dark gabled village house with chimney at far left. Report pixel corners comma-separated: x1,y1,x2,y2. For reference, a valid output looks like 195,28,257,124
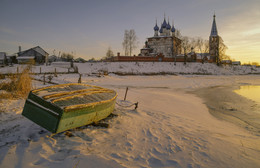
17,46,49,64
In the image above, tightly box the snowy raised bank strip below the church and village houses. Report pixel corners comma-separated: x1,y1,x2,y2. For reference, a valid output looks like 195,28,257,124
0,62,260,75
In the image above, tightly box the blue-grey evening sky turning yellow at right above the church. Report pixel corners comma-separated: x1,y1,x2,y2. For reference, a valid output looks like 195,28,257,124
0,0,260,63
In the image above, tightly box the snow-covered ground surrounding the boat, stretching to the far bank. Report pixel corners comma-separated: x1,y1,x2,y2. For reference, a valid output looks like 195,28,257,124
0,63,260,168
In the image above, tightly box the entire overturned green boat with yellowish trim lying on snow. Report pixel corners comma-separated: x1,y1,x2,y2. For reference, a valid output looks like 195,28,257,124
22,83,117,133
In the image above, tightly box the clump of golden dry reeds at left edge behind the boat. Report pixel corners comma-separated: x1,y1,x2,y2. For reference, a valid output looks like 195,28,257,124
0,66,32,98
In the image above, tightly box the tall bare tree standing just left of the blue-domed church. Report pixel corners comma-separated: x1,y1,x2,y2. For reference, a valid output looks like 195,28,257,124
122,29,137,56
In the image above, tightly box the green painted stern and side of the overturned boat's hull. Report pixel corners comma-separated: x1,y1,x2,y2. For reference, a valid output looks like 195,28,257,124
22,83,117,133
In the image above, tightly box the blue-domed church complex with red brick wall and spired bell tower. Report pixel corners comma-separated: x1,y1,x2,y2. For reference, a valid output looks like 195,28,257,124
105,14,232,64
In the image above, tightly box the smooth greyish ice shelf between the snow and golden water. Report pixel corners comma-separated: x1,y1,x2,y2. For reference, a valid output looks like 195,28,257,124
190,85,260,136
